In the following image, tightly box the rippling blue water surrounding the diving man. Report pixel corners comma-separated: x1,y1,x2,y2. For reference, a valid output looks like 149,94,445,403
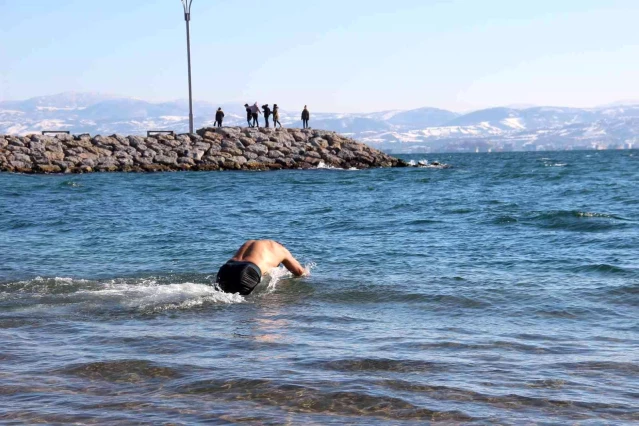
0,151,639,425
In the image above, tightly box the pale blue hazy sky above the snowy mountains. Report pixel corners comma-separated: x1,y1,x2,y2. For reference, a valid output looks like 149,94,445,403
0,0,639,112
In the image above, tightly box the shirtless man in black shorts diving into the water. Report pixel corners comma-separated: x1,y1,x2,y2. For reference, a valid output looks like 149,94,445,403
216,240,308,296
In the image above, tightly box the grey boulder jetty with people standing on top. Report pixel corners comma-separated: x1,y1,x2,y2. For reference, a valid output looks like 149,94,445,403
0,127,408,173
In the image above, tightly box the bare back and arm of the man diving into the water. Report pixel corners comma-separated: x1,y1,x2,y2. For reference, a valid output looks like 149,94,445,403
231,240,306,277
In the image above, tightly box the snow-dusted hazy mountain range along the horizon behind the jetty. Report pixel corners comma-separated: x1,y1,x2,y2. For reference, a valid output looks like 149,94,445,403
0,93,639,153
